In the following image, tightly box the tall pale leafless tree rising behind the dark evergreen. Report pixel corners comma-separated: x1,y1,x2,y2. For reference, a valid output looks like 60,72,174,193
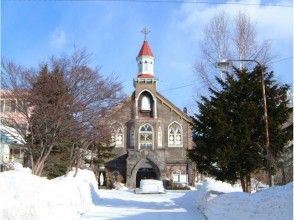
194,11,272,89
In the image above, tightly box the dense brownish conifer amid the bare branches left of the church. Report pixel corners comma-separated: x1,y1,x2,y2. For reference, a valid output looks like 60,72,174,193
27,65,74,176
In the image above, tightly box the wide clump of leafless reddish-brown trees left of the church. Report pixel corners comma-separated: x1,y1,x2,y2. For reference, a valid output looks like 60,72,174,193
1,50,123,175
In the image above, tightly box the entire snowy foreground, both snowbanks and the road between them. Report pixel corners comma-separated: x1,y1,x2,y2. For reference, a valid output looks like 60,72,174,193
0,167,293,220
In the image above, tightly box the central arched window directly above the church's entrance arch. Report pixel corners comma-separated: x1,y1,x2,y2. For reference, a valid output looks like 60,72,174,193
139,124,153,149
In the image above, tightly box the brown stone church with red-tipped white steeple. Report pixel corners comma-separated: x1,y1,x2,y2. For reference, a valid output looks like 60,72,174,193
105,37,195,188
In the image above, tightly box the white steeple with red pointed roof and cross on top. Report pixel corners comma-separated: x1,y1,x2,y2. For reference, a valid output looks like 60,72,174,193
136,28,154,78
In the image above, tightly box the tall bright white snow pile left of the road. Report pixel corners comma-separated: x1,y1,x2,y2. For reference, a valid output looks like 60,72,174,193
0,167,98,220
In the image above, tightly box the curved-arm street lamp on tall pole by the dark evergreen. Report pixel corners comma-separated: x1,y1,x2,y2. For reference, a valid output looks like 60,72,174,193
216,59,272,186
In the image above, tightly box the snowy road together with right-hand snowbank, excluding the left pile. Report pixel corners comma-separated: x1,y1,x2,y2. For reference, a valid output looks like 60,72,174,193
81,178,293,220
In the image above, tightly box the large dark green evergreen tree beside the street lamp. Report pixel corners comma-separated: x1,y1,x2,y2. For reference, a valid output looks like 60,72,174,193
188,67,291,191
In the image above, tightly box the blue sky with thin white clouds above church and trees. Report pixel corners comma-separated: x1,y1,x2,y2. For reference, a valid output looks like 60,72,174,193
1,0,293,111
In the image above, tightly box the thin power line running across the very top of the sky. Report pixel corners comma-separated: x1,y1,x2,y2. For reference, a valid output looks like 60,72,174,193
24,0,293,8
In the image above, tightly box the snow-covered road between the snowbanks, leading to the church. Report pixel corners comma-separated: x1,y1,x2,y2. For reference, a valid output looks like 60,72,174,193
81,190,205,220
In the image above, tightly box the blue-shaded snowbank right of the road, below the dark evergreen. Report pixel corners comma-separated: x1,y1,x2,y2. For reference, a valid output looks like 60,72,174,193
197,179,293,220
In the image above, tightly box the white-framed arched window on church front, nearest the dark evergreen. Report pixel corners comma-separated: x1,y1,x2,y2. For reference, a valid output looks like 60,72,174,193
168,122,183,147
